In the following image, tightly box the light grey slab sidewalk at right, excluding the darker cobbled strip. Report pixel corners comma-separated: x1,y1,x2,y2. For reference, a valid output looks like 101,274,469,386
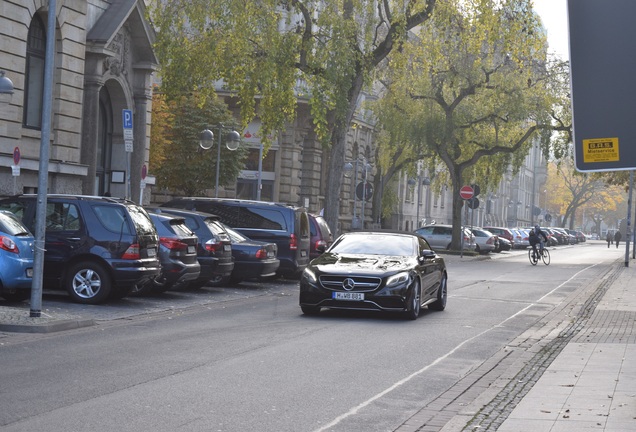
496,260,636,432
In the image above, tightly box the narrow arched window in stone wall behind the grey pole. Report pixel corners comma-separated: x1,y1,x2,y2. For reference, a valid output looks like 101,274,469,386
23,15,46,129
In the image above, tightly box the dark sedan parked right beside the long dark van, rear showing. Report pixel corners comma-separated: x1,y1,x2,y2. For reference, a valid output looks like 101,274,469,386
224,225,280,285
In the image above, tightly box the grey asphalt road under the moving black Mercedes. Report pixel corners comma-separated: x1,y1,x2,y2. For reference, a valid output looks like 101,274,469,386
0,242,624,432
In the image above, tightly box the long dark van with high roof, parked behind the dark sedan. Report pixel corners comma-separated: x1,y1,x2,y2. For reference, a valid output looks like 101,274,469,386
162,197,310,278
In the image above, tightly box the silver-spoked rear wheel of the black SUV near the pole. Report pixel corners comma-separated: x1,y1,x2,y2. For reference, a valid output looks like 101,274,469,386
66,261,111,304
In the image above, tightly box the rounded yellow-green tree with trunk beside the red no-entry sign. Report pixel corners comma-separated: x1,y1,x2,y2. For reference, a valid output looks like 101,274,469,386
372,0,570,249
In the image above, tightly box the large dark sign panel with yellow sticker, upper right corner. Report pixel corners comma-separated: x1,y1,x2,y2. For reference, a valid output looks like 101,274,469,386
568,0,636,171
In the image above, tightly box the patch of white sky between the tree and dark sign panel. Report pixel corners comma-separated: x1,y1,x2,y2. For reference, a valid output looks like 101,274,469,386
534,0,570,60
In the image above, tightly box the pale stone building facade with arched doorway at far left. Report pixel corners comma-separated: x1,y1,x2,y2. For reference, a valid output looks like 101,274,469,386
0,0,157,200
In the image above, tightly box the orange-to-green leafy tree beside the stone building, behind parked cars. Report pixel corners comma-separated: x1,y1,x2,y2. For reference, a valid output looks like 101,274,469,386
150,91,247,196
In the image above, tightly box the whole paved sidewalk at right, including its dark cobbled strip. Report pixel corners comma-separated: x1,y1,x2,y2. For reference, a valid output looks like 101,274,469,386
396,260,636,432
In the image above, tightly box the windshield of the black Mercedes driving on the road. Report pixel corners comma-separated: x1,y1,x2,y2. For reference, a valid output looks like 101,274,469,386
329,234,416,256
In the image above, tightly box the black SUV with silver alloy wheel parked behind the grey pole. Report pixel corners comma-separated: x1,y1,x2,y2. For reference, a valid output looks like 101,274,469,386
0,195,161,304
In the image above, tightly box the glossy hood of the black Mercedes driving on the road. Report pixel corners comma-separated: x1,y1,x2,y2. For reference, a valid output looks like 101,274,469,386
311,253,414,273
